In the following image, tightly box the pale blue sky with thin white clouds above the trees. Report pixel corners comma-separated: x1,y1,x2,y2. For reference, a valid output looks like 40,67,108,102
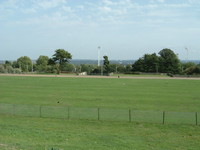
0,0,200,60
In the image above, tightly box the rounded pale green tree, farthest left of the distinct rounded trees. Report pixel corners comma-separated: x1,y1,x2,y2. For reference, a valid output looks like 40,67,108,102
17,56,32,72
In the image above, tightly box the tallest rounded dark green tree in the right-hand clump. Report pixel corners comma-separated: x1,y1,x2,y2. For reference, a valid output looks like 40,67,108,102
158,48,181,74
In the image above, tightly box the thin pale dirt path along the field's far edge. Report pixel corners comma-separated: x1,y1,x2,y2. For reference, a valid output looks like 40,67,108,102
0,74,200,80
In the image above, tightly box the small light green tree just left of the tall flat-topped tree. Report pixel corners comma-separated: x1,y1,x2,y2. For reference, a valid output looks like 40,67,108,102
36,56,49,72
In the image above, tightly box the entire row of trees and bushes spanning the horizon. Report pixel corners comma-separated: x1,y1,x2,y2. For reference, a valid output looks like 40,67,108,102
0,48,200,75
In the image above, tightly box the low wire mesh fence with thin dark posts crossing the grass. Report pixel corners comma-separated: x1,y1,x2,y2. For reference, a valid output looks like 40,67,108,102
0,104,200,125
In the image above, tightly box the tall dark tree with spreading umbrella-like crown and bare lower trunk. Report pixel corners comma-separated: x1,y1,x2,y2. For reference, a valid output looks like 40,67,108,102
52,49,72,74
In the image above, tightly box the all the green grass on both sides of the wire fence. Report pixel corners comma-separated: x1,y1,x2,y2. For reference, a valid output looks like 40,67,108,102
0,76,200,150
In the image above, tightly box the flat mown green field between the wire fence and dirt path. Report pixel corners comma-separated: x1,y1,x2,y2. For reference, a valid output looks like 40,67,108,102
0,76,200,112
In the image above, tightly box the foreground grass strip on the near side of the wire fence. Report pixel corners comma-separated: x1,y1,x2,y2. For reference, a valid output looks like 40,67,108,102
0,115,200,150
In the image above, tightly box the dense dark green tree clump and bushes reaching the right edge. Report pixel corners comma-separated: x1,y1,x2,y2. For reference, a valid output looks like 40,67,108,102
132,48,200,75
